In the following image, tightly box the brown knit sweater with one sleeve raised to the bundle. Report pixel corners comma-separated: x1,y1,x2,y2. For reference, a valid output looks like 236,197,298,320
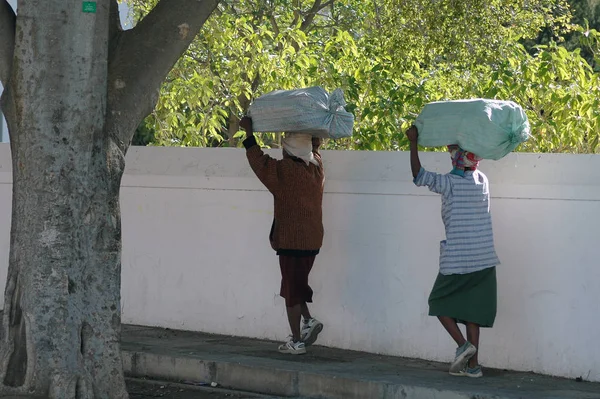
244,136,325,251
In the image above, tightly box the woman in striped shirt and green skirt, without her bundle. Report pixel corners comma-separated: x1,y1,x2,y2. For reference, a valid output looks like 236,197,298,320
406,126,500,378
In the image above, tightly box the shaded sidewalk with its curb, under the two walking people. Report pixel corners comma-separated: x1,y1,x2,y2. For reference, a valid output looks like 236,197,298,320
122,326,600,399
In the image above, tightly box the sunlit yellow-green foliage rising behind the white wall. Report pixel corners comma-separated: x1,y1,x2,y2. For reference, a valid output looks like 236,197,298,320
131,0,600,152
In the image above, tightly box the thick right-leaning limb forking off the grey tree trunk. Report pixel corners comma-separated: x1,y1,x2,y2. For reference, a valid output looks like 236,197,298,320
107,0,219,152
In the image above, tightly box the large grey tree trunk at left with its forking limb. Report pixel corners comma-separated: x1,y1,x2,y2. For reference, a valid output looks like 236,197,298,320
0,0,218,399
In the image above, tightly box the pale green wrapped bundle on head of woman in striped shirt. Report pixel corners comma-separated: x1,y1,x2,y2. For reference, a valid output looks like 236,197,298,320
415,99,530,160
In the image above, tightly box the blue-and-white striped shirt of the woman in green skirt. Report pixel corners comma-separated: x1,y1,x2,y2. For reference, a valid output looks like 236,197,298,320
414,168,500,275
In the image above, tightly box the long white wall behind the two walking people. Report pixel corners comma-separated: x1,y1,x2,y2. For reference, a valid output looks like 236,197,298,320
0,145,600,381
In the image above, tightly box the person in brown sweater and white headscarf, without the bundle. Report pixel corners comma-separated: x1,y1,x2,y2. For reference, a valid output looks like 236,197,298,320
240,117,325,354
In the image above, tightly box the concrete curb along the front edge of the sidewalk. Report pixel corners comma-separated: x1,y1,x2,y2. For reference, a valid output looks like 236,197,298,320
122,350,515,399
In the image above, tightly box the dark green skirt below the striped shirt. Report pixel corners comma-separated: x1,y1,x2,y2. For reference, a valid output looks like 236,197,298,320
429,267,496,327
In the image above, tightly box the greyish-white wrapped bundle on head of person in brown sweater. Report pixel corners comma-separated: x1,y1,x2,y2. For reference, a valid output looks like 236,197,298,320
248,86,354,139
